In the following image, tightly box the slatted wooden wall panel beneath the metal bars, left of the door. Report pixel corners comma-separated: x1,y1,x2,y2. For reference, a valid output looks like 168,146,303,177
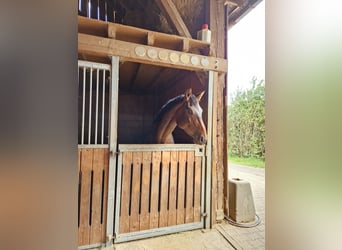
78,148,109,246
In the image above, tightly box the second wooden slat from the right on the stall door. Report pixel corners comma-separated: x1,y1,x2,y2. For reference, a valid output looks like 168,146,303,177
185,151,194,223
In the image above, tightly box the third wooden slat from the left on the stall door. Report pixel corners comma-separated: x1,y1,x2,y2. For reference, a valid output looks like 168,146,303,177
140,152,152,230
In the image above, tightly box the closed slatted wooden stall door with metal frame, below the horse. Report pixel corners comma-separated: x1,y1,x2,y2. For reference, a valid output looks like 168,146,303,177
115,144,204,242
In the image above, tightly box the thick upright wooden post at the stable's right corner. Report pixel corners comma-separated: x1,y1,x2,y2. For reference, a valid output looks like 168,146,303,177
206,0,227,224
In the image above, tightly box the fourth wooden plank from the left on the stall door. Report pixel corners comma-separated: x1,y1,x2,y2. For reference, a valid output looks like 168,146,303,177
150,151,161,228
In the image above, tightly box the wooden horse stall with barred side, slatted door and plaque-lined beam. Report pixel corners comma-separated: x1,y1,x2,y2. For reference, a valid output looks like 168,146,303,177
78,1,236,249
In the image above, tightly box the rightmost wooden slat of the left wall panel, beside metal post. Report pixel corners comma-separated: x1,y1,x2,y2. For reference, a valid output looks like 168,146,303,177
101,148,109,242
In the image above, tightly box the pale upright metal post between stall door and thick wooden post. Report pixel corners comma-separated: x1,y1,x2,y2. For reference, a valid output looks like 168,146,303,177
204,71,214,228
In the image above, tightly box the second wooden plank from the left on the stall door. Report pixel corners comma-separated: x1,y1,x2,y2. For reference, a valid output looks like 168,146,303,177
129,152,143,232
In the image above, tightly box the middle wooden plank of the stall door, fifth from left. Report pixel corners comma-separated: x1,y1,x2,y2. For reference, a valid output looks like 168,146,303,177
159,151,170,227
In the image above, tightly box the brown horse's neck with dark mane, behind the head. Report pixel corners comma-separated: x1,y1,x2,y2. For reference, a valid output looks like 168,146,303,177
156,103,182,143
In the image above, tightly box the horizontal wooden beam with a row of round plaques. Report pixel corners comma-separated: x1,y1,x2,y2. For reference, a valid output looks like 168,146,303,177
78,33,227,72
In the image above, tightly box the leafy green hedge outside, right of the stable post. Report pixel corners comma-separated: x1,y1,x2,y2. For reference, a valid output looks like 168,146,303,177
228,77,265,160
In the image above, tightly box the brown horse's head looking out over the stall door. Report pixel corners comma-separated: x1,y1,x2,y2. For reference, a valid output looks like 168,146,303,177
176,89,207,144
